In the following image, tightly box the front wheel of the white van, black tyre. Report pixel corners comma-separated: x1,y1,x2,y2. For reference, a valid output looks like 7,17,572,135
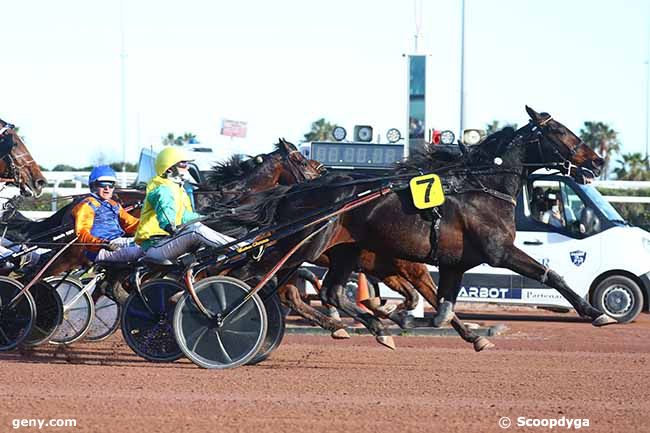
593,275,643,323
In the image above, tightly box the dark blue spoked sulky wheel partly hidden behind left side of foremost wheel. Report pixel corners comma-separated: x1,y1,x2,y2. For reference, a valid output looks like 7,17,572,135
122,279,185,362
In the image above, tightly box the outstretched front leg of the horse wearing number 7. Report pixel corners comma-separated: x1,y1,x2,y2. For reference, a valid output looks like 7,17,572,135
498,246,616,326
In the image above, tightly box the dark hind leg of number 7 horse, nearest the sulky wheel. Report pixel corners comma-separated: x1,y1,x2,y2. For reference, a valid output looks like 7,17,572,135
320,247,395,350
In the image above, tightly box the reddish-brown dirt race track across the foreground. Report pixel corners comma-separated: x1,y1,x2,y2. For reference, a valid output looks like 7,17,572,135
0,314,650,433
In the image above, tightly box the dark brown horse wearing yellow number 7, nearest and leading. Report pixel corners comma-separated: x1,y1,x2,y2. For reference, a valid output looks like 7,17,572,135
224,107,613,344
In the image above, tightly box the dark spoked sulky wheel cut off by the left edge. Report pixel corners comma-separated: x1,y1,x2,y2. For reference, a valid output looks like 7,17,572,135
0,276,36,351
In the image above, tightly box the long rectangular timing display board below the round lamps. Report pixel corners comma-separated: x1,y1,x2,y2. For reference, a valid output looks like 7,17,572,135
311,141,404,168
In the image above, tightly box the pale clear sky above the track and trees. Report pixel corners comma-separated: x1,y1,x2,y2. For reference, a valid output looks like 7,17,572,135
0,0,650,167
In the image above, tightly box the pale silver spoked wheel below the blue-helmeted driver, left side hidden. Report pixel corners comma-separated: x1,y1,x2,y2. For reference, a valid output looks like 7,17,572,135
48,277,95,344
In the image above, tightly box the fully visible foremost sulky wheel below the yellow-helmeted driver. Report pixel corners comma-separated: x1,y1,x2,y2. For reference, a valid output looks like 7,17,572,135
174,277,267,369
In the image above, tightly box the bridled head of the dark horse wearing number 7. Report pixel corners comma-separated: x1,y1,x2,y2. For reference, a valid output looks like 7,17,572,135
526,106,605,177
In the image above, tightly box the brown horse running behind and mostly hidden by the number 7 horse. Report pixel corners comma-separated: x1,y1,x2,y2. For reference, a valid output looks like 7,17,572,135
197,147,492,351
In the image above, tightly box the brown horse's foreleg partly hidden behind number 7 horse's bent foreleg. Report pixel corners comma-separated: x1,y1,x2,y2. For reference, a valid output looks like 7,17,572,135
398,262,494,352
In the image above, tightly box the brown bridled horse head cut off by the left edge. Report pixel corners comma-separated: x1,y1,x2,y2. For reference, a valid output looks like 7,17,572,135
0,119,47,197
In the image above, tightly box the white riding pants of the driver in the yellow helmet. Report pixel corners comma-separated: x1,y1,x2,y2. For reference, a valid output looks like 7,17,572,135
145,222,235,261
